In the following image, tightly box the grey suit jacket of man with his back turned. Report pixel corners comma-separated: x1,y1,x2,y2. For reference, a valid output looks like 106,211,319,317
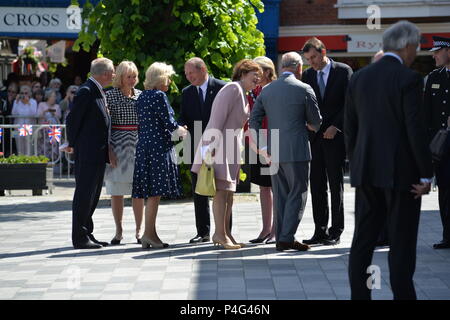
246,74,322,162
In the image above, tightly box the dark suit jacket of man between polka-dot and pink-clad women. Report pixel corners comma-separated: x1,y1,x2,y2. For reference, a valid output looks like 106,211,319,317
178,75,226,162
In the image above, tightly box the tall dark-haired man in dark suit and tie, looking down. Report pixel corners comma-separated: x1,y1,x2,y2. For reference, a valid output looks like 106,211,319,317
302,38,353,245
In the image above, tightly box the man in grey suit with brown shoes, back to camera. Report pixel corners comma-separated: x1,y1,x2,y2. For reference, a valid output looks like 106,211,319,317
250,52,322,251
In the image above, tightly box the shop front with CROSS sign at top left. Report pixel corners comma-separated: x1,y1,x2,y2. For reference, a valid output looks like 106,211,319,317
0,0,98,86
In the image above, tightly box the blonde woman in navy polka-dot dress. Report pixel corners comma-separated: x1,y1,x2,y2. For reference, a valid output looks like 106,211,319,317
133,62,187,248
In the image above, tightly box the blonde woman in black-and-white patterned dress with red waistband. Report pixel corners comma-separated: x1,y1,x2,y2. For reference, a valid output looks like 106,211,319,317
105,61,144,245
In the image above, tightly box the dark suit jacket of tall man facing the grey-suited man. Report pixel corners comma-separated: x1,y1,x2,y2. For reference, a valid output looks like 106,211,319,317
302,59,353,141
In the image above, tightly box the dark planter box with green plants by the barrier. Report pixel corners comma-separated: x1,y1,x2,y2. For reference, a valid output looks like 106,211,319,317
0,155,51,195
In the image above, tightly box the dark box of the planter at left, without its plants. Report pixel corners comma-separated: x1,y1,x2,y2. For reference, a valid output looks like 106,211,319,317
0,163,52,196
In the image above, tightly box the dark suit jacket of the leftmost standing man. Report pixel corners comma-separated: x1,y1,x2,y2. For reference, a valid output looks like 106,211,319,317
66,79,111,163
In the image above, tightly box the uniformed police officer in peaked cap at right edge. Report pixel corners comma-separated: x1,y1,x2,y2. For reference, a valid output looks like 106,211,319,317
424,36,450,249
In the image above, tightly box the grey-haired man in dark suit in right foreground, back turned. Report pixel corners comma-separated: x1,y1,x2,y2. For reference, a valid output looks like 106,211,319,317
344,21,433,300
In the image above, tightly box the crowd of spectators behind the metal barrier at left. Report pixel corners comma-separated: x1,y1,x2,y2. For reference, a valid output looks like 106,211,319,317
0,73,79,159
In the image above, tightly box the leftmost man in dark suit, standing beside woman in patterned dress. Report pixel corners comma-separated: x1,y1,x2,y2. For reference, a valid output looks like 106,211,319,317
66,58,115,249
